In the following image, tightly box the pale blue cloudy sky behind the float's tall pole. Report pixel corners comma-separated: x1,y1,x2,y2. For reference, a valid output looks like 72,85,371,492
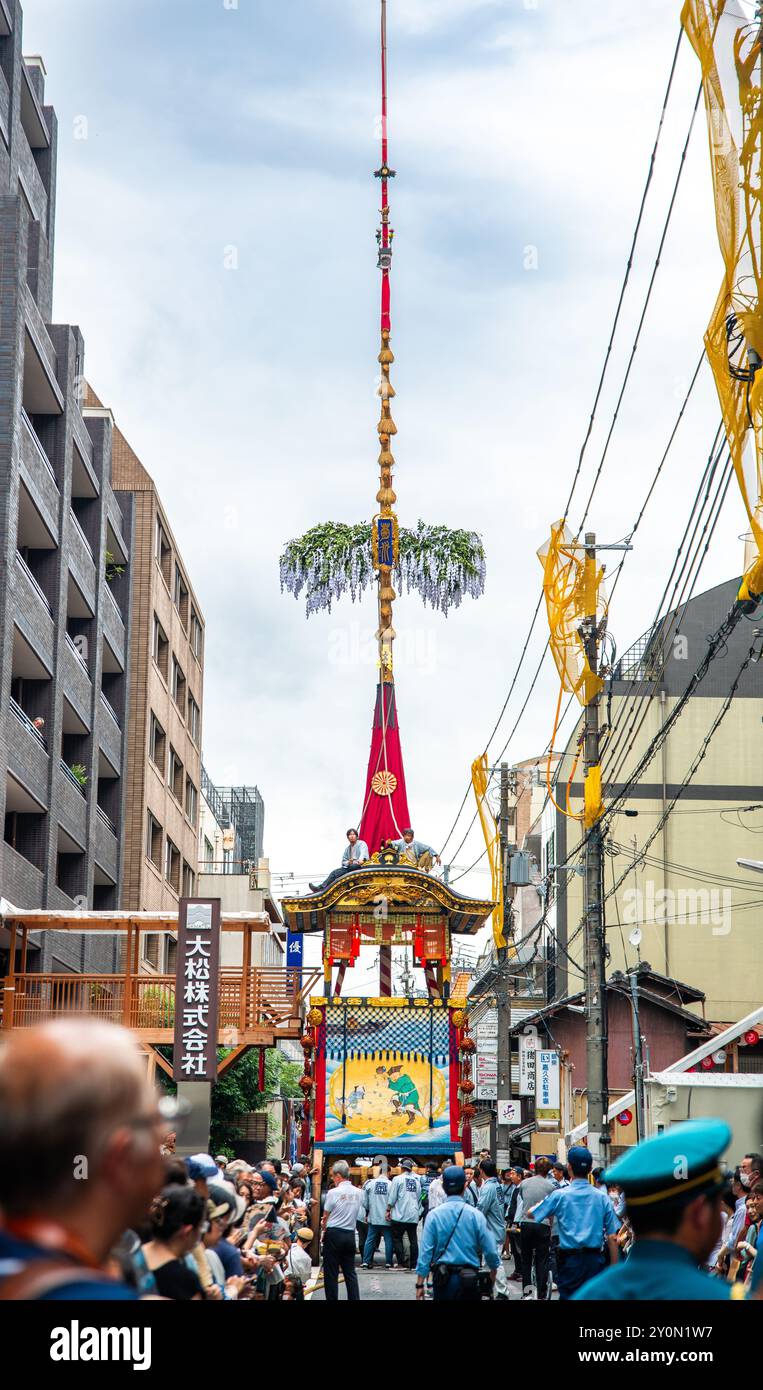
25,0,744,934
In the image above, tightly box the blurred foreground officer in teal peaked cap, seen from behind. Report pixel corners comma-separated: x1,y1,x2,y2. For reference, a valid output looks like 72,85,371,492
574,1119,744,1302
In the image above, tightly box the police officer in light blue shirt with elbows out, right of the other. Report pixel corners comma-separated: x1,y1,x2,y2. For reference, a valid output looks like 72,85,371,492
525,1145,621,1300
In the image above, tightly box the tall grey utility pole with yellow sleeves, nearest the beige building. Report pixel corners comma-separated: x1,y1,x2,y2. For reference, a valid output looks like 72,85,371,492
582,531,610,1162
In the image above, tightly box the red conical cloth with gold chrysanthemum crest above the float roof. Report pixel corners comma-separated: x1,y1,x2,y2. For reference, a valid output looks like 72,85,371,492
360,681,410,855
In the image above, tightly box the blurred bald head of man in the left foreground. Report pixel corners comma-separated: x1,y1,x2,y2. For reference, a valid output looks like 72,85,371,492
0,1019,161,1219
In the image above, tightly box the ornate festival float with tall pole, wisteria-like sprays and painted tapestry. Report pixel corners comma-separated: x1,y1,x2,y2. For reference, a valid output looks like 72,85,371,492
281,0,496,1184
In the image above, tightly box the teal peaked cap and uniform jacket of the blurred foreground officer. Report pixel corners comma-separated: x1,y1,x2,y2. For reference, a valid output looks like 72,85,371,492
573,1119,732,1302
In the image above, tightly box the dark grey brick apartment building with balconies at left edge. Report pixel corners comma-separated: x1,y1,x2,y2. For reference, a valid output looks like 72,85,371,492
0,0,132,970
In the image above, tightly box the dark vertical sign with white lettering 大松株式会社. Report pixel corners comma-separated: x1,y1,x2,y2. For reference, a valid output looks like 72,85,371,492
172,898,220,1081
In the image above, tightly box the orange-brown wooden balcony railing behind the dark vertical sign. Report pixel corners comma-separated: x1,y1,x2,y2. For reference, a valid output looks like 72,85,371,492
0,966,300,1034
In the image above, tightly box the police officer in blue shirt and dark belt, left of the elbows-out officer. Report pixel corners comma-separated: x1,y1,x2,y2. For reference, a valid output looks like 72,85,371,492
416,1166,500,1302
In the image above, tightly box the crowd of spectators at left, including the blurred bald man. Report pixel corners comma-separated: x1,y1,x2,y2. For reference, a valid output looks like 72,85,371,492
0,1020,314,1301
